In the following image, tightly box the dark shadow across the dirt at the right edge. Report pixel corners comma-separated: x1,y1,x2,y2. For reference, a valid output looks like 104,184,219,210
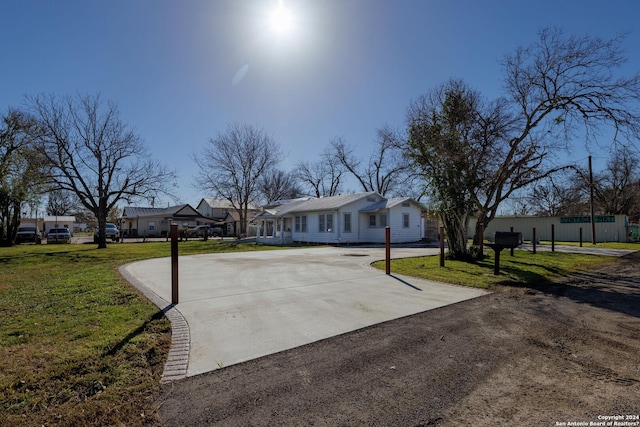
504,252,640,317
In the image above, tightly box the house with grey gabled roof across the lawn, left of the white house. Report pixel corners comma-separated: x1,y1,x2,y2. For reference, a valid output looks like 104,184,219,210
117,204,218,237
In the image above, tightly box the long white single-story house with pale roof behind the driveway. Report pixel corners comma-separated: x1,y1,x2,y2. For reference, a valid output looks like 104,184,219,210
256,192,424,244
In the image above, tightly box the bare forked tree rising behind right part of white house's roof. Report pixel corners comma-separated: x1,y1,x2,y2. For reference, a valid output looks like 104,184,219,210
331,130,413,196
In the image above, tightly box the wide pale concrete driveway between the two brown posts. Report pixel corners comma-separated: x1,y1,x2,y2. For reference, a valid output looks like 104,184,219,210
121,247,486,381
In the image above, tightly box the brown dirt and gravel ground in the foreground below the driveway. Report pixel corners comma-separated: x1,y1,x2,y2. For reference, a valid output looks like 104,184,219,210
158,252,640,426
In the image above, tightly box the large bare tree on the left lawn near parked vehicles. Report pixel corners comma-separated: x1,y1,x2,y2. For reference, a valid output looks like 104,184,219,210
27,95,175,248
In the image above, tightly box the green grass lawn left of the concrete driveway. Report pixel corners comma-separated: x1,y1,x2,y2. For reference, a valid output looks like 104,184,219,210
0,240,280,426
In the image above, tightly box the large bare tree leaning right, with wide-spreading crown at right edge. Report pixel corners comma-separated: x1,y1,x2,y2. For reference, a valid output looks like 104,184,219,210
475,29,640,241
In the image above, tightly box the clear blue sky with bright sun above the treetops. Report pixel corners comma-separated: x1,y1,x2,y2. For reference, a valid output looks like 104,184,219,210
0,0,640,206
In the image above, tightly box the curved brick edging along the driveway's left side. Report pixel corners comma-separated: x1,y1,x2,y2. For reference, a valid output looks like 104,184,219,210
119,264,191,384
